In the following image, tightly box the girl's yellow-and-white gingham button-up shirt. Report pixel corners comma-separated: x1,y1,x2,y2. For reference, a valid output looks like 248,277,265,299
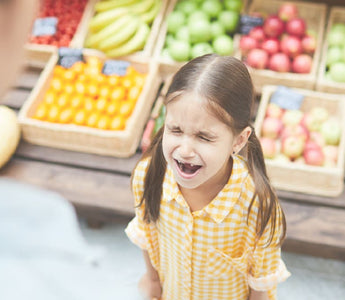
125,156,290,300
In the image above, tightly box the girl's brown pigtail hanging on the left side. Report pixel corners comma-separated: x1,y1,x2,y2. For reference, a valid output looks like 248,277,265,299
135,126,166,223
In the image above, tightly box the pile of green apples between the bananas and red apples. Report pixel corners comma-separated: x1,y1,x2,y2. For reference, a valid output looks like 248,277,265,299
162,0,243,61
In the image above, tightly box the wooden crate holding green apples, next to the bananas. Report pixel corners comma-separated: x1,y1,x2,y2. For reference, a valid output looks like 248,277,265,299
153,0,249,67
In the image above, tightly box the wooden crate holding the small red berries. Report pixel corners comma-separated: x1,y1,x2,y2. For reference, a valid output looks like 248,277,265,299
24,0,99,68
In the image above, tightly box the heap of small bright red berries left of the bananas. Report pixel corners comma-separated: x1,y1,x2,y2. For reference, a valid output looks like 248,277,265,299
29,0,87,47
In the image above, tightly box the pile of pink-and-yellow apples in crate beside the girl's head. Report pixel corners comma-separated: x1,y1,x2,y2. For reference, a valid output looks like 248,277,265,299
260,102,342,167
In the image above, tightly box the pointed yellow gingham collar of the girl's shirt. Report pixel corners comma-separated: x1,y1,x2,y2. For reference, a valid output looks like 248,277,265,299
162,156,248,223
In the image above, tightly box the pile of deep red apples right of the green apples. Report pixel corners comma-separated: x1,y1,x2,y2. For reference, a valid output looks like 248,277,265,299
239,3,316,73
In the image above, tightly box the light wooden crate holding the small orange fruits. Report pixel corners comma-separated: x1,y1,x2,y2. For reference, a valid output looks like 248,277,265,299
19,49,159,157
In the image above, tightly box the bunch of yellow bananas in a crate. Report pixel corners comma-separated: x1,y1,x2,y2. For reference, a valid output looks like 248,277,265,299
84,0,162,57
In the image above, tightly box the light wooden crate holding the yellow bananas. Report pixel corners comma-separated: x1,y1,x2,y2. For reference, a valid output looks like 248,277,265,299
77,0,169,57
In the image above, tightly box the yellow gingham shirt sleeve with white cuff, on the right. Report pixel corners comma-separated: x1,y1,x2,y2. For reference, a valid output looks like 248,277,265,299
243,177,291,300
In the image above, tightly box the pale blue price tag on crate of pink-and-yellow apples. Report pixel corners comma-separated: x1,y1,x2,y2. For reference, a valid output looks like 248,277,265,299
271,86,304,110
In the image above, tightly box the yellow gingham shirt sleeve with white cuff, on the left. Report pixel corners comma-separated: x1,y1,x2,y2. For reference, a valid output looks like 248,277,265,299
125,161,148,250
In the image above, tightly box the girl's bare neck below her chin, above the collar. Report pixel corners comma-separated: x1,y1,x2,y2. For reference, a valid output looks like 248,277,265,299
180,159,233,212
